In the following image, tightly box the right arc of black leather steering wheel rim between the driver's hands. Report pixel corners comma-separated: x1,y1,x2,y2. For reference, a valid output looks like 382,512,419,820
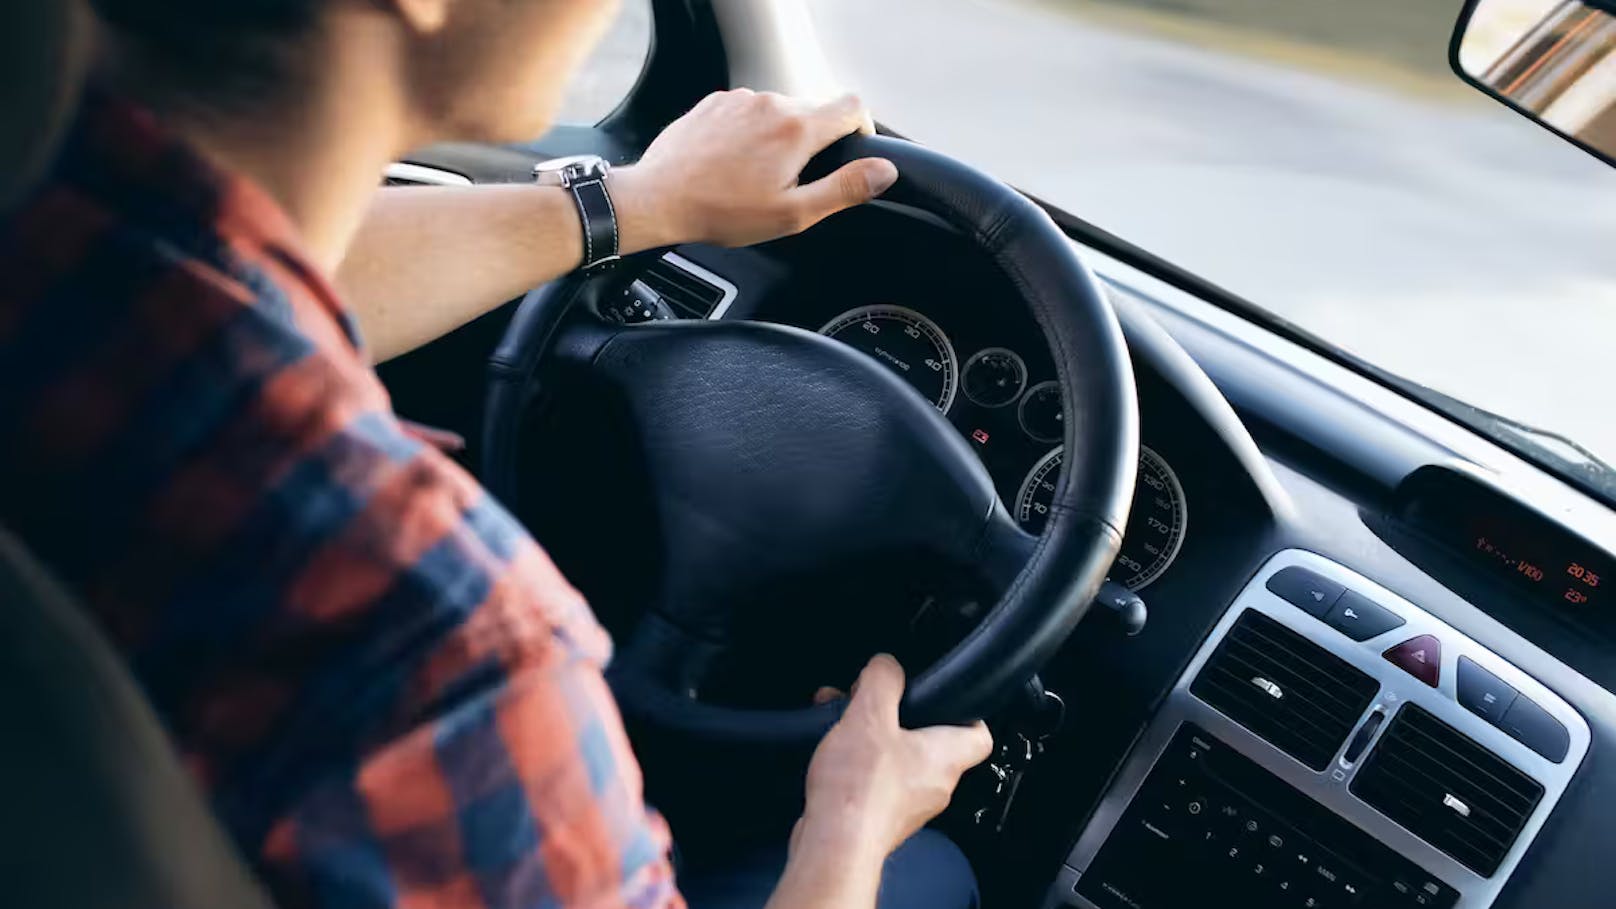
805,137,1139,723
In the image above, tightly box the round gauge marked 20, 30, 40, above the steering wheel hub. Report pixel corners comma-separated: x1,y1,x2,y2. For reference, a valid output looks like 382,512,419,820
819,306,960,412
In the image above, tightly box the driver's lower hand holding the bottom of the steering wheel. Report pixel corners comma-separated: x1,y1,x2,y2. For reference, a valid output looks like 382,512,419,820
792,655,994,864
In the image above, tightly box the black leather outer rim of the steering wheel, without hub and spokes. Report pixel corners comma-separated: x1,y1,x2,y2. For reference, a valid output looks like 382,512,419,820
483,136,1139,741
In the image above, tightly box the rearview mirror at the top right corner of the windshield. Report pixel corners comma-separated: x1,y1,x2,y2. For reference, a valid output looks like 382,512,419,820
1450,0,1616,165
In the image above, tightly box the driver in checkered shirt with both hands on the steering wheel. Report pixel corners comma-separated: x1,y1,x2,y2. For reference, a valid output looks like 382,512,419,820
0,0,991,909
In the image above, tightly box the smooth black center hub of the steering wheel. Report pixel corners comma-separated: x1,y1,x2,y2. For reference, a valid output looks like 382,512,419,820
591,322,997,634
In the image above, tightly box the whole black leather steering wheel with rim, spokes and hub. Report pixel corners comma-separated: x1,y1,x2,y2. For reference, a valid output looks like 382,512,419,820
483,136,1139,744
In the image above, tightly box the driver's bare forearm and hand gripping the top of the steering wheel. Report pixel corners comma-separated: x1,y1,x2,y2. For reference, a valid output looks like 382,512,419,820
338,91,898,361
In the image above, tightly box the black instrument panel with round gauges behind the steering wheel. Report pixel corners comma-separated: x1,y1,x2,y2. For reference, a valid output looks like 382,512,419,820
601,199,1228,592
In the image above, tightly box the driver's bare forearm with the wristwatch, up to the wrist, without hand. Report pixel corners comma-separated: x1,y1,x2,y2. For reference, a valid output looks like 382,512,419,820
338,168,674,362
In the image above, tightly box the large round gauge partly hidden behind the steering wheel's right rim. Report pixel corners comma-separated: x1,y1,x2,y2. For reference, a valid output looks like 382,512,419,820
1015,445,1189,590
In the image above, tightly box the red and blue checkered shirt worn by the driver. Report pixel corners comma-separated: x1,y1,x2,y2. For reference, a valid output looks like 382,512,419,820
0,97,682,909
